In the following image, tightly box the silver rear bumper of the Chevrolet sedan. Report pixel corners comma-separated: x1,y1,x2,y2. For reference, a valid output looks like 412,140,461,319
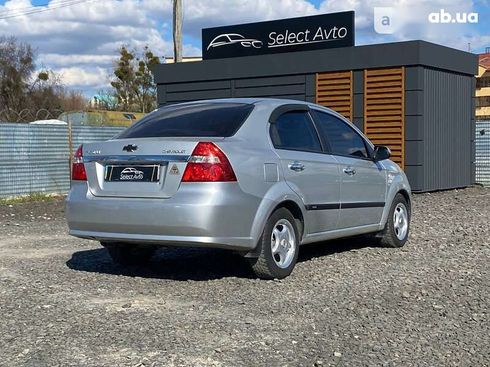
66,182,260,251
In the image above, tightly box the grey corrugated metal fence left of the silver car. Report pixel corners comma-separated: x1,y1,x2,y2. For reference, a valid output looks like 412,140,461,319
0,123,124,197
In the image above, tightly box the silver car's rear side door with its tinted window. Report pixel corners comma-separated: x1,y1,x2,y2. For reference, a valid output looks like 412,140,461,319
270,110,340,233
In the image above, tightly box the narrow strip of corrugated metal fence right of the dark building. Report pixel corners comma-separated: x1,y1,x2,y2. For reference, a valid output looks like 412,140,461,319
475,121,490,186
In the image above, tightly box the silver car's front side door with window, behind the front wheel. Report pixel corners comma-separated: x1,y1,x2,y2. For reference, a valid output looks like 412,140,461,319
312,110,386,229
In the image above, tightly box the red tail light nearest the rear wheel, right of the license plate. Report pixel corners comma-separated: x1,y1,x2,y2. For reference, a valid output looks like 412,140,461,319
182,142,237,182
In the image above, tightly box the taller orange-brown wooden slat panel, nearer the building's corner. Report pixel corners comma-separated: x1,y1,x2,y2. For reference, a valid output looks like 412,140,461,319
364,67,405,168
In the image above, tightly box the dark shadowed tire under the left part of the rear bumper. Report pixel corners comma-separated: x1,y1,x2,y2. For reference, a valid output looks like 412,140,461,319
101,242,156,266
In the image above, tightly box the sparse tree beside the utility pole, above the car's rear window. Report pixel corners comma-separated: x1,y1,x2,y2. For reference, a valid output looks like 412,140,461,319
111,46,160,112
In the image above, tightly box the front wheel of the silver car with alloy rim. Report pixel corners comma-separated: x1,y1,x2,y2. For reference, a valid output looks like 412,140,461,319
378,194,411,247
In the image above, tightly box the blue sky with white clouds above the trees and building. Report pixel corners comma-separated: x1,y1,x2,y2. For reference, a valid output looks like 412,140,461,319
0,0,490,96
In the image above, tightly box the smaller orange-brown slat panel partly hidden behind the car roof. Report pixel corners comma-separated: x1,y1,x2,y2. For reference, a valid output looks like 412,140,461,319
316,71,352,120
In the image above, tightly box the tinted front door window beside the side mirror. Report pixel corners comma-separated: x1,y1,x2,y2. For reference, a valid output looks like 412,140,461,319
313,110,369,158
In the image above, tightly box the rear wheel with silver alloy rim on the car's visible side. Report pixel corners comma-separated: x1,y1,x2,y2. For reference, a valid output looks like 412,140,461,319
249,208,300,279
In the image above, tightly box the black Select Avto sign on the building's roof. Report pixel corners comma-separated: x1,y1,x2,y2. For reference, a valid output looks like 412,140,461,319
202,11,354,59
